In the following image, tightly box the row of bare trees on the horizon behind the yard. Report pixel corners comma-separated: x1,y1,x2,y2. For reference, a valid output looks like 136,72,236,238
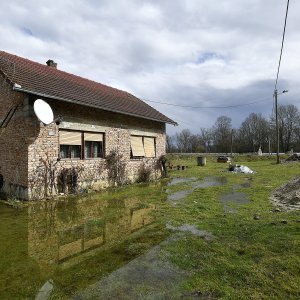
167,105,300,153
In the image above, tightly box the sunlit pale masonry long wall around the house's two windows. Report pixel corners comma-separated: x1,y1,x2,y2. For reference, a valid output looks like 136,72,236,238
28,99,166,199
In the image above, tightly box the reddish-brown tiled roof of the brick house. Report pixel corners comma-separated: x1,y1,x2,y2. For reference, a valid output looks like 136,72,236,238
0,51,176,125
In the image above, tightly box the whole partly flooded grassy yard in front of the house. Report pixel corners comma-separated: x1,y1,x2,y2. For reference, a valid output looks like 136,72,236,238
0,156,300,299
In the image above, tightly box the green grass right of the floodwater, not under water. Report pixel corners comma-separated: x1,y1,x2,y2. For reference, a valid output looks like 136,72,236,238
161,156,300,299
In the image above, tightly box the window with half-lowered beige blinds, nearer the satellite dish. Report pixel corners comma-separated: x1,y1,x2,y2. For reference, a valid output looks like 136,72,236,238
59,130,104,159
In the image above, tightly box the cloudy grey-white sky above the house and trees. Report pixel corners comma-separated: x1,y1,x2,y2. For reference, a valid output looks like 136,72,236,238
0,0,300,134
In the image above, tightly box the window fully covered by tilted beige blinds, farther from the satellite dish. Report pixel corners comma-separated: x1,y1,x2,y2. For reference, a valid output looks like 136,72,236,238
130,135,156,158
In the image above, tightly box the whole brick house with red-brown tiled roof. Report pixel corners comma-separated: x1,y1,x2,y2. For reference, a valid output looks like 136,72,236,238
0,51,176,199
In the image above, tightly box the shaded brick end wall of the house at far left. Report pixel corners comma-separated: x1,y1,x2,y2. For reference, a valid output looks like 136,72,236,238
0,81,32,198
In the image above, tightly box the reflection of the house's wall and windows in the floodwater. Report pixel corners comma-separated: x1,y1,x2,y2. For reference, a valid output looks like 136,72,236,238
28,195,156,266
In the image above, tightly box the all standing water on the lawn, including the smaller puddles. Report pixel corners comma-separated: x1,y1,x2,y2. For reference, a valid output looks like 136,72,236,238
0,177,253,300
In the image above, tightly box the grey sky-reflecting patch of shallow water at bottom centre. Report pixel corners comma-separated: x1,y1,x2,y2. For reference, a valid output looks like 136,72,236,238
73,240,189,300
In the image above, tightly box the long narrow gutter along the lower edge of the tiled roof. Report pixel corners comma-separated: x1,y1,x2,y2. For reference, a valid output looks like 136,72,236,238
13,84,178,126
